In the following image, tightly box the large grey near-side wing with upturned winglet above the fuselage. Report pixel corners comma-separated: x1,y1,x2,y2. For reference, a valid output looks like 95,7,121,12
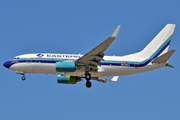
76,25,120,70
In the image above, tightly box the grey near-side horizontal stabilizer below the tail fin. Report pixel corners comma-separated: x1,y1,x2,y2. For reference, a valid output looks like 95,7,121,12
152,49,176,63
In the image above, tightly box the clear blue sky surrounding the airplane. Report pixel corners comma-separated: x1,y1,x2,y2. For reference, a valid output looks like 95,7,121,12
0,0,180,120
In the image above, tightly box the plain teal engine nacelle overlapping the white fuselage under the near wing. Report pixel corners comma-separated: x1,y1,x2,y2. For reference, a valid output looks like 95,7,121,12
56,62,75,72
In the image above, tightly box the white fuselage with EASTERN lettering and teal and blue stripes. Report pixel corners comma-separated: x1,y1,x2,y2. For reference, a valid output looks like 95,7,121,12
9,54,166,77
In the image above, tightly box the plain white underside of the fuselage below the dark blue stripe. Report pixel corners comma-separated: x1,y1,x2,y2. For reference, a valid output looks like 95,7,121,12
10,63,163,77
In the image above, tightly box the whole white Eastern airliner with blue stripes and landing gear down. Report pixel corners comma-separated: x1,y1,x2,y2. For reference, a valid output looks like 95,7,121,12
3,24,175,88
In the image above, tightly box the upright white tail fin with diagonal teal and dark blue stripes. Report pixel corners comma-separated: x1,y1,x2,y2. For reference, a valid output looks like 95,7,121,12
140,24,176,59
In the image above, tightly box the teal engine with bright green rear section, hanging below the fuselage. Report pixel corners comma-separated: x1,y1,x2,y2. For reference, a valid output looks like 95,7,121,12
57,75,81,84
